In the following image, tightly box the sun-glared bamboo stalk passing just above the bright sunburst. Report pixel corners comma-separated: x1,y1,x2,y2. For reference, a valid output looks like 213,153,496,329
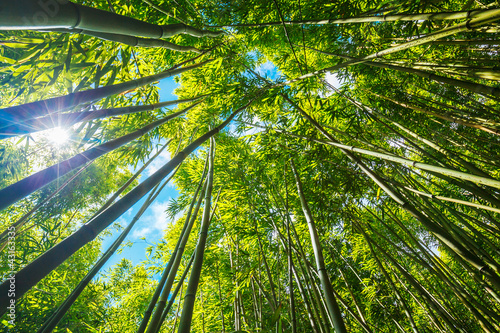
0,97,200,140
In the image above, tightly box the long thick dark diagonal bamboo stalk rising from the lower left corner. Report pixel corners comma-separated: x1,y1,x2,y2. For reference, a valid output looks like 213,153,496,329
0,99,253,316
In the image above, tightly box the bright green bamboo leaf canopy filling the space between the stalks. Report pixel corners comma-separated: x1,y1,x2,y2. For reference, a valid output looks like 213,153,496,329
0,0,500,333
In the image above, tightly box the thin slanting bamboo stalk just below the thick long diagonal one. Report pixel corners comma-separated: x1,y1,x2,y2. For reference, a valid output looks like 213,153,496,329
38,168,179,333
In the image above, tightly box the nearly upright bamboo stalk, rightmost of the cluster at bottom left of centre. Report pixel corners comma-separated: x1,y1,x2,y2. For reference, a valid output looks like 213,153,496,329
176,138,215,333
